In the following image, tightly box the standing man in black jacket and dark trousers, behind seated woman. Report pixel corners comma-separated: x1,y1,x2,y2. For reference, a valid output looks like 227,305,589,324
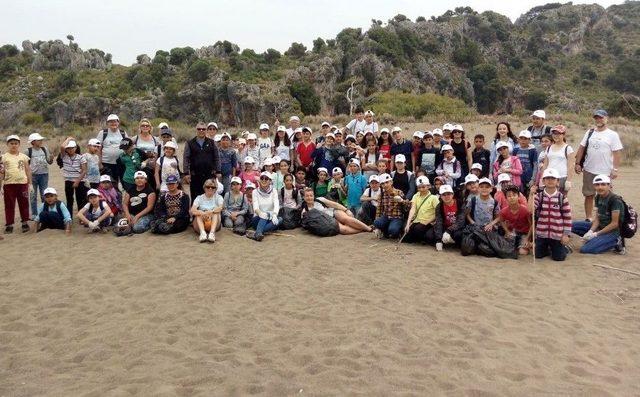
182,122,221,200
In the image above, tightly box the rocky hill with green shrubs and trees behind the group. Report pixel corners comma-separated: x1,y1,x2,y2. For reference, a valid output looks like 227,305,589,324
0,1,640,129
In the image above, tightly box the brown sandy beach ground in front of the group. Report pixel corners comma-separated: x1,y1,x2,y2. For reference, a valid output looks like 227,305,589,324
0,162,640,396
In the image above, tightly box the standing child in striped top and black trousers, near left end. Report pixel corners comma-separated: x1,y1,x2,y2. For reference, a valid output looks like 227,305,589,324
60,137,87,214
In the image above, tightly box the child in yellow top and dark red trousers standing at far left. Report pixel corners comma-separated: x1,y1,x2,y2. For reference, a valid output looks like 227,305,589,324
0,135,31,233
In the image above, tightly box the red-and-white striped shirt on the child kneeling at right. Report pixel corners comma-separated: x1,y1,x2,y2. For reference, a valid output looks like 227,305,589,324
533,190,571,240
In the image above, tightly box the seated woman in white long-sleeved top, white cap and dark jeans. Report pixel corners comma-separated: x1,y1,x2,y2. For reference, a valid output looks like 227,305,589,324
247,171,282,241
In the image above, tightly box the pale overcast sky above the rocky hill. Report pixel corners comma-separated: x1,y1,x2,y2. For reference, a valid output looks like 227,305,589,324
0,0,622,65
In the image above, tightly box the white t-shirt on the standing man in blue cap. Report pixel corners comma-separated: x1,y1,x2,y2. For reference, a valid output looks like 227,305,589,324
580,128,623,175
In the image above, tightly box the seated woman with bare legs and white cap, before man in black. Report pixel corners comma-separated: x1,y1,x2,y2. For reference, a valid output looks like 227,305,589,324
189,177,224,243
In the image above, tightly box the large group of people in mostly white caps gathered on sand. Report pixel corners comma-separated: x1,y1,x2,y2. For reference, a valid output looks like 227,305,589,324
0,109,632,260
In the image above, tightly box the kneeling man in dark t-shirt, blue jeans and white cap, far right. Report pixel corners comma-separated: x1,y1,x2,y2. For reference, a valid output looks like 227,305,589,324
572,174,625,255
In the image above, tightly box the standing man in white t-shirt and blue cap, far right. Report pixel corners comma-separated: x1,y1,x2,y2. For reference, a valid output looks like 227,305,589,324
575,109,623,222
